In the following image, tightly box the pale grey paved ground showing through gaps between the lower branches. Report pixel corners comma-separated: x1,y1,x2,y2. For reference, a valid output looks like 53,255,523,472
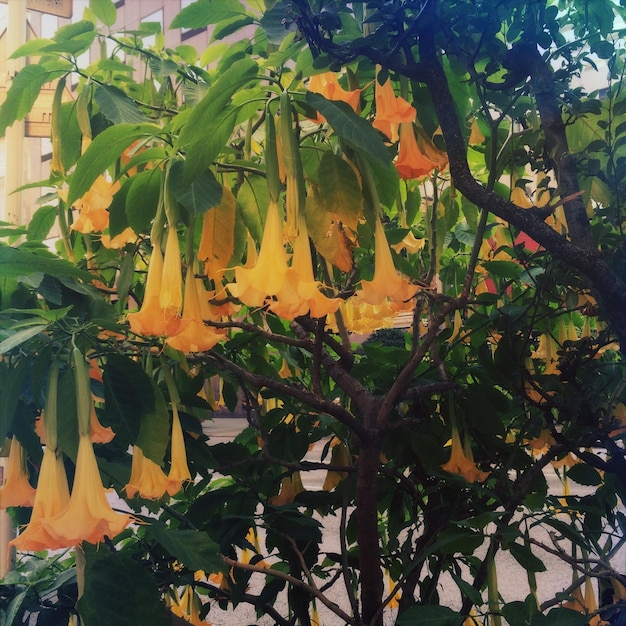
205,418,626,626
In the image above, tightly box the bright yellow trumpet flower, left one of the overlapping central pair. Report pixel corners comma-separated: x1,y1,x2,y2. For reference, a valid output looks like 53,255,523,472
228,201,287,307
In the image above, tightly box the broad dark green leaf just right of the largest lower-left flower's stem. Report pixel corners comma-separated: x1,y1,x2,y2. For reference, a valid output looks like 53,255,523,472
102,354,156,445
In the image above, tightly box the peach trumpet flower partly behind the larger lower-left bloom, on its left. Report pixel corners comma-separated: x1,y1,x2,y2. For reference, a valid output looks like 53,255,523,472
10,447,70,552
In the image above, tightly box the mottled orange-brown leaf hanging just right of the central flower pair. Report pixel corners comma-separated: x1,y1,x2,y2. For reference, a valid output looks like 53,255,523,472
304,188,354,272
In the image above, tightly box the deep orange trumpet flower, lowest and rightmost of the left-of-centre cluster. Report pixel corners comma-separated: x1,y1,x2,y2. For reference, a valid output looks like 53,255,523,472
166,265,226,354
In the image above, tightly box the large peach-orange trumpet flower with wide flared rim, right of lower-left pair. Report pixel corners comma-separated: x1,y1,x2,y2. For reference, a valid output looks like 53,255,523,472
43,434,131,547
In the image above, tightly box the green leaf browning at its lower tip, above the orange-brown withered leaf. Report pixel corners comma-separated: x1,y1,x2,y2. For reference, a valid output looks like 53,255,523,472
318,152,363,232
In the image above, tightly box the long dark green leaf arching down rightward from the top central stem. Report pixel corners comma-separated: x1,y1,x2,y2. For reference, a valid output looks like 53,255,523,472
306,91,391,165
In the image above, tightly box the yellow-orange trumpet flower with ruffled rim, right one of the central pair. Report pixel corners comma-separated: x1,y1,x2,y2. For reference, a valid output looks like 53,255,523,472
269,220,341,320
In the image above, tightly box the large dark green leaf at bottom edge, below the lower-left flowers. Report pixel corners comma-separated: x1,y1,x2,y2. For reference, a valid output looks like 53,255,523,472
76,547,172,626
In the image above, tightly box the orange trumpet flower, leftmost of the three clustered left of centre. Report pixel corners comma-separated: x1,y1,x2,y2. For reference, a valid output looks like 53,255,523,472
127,245,182,337
